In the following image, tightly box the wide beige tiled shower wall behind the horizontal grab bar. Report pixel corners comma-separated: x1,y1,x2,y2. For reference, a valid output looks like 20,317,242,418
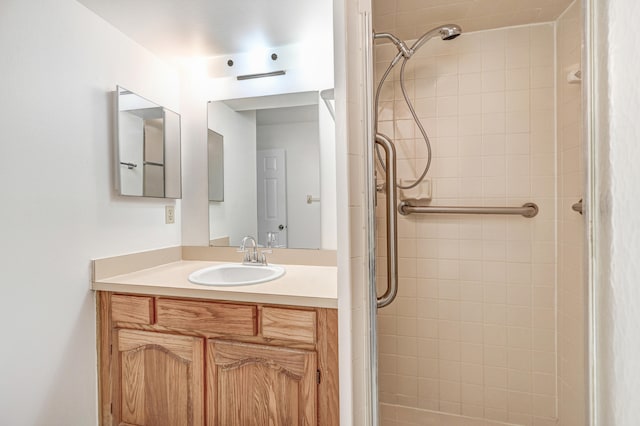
376,24,557,426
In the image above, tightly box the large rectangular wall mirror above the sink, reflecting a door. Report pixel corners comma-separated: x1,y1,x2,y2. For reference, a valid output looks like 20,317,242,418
207,91,336,249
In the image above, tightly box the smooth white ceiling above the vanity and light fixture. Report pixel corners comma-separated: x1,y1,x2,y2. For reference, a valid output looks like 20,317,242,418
78,0,332,58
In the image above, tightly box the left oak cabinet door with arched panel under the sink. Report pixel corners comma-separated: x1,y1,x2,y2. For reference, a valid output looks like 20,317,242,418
113,330,204,426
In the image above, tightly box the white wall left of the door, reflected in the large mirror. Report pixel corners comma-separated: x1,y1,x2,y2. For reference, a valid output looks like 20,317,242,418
205,102,258,246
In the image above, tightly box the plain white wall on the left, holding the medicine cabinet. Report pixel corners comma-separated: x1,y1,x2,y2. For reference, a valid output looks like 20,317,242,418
0,0,180,426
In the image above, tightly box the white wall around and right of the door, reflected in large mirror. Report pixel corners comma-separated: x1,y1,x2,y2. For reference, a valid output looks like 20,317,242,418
257,109,322,248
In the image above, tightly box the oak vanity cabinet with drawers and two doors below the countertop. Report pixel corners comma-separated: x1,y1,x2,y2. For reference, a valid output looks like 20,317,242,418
98,292,339,426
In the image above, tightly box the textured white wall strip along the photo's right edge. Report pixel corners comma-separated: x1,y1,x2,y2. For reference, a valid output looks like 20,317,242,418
590,0,640,426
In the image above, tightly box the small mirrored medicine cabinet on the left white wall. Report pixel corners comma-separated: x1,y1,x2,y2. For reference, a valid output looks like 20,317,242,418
116,86,182,198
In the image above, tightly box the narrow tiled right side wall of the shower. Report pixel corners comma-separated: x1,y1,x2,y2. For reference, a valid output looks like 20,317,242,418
557,2,587,426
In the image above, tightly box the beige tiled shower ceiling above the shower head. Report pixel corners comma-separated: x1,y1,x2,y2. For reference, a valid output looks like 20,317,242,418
372,0,574,40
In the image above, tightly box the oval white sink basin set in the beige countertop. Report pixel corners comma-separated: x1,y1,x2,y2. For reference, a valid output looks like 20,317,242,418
189,263,285,286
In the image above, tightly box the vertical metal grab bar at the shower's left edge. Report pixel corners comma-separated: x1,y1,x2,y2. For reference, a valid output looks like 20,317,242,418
375,133,398,308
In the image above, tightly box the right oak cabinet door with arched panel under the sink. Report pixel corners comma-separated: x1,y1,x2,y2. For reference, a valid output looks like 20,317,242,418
207,340,317,426
